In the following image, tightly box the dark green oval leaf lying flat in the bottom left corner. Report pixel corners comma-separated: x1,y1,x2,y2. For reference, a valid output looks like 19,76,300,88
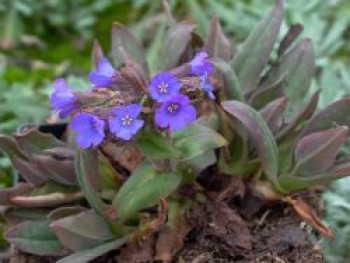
5,221,66,256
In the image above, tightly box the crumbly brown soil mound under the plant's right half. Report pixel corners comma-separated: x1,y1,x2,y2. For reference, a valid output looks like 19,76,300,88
177,193,324,263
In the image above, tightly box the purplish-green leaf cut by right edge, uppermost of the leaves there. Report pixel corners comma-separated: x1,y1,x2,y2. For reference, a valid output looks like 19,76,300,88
301,99,350,136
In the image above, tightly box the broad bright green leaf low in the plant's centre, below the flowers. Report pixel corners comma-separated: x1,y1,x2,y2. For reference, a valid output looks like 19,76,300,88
113,164,181,221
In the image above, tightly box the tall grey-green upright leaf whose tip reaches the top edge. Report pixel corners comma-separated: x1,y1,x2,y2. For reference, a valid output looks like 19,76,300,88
231,0,283,91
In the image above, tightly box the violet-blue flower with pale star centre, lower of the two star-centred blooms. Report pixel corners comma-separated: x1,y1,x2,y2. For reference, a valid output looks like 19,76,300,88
109,103,144,141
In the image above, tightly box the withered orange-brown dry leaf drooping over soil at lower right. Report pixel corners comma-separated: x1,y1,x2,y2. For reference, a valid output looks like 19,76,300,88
284,197,335,240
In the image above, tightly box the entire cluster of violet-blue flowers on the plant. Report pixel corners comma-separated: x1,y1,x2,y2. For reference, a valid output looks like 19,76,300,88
51,51,215,148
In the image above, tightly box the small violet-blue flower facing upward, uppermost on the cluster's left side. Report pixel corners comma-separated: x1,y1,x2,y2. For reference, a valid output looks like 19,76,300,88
90,58,116,88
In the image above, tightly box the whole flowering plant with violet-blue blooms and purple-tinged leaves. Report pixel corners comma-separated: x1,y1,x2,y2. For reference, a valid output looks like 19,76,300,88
0,0,350,262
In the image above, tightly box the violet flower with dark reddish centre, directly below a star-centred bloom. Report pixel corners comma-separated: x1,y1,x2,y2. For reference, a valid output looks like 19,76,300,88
155,94,196,131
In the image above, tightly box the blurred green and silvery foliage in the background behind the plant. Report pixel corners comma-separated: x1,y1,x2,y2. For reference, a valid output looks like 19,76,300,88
0,0,350,262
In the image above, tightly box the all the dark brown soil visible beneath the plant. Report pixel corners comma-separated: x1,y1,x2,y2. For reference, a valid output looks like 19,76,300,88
4,192,324,263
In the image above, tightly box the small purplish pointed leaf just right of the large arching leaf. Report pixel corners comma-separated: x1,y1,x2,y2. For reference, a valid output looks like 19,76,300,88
260,97,288,134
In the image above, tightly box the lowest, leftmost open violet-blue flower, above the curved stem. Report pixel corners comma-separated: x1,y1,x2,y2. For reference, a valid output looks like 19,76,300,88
70,113,105,148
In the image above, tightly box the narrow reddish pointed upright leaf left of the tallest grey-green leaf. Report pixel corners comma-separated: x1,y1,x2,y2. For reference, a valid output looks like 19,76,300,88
204,15,233,61
